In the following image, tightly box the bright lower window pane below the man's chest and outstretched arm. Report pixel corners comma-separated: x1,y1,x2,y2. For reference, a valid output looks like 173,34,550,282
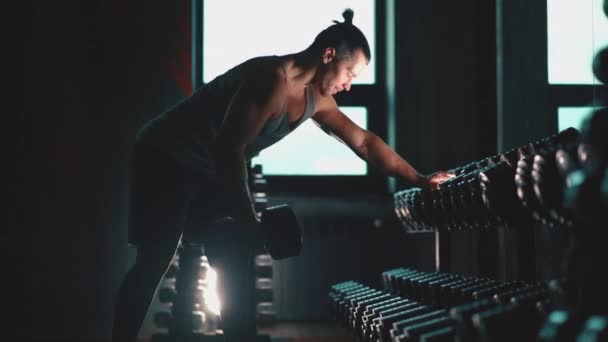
252,107,367,176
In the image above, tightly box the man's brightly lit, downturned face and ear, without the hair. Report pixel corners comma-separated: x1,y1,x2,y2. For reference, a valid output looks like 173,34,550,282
320,49,369,96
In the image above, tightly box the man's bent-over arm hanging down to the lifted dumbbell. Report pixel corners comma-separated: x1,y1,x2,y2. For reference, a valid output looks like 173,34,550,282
213,66,286,223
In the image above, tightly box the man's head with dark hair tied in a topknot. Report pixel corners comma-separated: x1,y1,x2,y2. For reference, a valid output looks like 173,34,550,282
307,9,371,95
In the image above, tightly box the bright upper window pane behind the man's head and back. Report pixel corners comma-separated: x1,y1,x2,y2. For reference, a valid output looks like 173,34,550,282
203,0,376,84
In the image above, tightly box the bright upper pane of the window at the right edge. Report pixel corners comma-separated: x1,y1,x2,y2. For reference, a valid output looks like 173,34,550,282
547,0,608,84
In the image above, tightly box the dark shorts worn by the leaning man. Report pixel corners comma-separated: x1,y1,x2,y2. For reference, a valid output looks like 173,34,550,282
129,145,230,246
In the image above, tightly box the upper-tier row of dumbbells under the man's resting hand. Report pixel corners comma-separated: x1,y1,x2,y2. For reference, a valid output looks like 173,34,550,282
394,128,580,232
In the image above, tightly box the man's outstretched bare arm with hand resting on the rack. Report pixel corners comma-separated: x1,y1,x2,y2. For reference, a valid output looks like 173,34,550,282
313,100,452,188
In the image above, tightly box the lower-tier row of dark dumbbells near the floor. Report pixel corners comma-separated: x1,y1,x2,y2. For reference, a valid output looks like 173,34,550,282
329,268,554,341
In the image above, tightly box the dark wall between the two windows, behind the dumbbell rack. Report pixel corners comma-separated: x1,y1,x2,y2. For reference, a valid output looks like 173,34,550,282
396,0,496,274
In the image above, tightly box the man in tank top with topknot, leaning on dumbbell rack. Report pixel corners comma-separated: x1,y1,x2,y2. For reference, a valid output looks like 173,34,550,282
113,9,453,341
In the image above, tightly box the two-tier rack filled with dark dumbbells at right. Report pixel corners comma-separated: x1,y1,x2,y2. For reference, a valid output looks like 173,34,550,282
330,117,608,341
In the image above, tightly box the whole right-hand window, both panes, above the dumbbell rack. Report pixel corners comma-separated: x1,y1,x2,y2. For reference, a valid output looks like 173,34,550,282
547,0,608,131
